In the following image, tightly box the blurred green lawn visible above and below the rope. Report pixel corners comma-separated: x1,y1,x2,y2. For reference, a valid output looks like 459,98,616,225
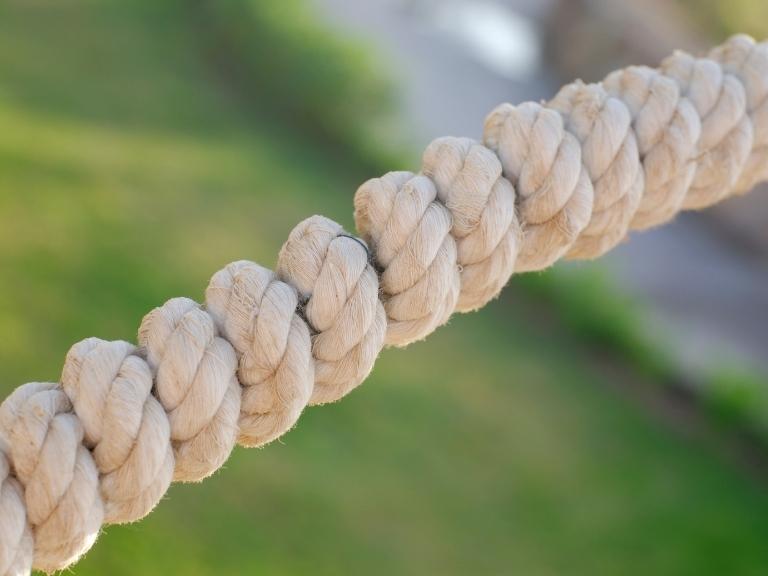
0,0,768,576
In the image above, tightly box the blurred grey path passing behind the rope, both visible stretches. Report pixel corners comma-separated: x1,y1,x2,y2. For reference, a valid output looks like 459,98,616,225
314,0,768,374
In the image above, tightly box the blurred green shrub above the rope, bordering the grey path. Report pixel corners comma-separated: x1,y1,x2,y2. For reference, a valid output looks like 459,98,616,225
194,0,394,166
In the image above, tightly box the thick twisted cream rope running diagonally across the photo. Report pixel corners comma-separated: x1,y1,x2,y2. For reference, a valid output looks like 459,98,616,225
0,36,768,575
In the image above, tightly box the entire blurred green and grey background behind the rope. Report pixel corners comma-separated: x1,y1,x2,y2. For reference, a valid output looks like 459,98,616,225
0,0,768,576
